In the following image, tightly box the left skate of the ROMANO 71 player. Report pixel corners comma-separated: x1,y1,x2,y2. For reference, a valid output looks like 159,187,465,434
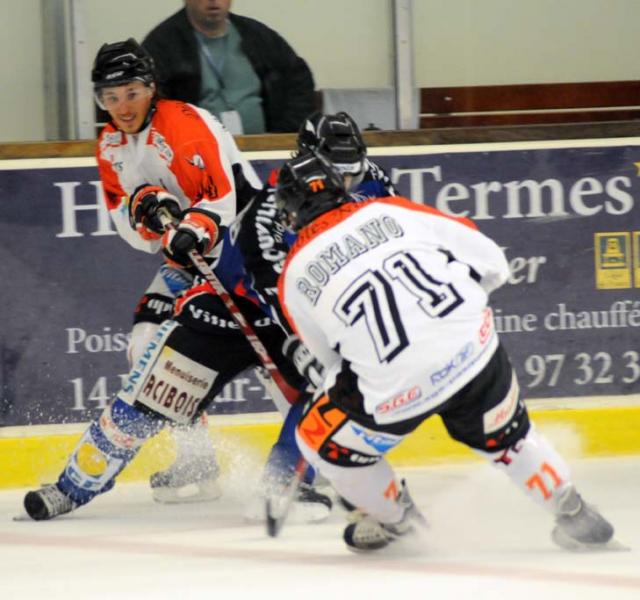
343,481,427,552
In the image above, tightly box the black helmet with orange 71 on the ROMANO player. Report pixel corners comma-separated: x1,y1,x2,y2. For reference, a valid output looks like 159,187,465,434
276,153,349,231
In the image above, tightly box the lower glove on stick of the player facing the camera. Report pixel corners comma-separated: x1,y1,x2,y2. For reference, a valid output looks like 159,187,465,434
162,209,218,267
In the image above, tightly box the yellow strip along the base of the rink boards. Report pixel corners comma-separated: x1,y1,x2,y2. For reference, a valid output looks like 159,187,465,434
0,395,640,488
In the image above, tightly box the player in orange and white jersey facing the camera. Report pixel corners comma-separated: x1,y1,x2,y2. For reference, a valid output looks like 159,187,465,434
92,39,262,501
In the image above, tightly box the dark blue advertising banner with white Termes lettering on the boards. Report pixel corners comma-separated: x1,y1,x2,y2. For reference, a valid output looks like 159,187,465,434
0,140,640,426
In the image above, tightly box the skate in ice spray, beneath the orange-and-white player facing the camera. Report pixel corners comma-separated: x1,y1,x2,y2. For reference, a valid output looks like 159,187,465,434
149,456,222,504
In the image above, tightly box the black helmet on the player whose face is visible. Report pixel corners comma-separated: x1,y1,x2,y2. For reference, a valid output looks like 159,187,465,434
91,38,156,90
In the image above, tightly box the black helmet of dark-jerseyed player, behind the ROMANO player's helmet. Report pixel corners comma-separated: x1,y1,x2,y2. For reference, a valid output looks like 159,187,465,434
298,112,367,176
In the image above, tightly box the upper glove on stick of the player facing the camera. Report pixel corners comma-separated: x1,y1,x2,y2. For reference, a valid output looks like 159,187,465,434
129,185,182,240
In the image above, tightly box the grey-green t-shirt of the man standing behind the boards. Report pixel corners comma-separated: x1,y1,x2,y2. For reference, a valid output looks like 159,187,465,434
196,22,265,133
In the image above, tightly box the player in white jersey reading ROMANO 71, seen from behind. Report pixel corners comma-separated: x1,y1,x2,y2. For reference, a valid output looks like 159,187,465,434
276,154,613,551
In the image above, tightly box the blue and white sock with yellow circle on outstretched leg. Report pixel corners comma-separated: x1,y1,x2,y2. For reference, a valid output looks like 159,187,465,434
58,399,164,505
